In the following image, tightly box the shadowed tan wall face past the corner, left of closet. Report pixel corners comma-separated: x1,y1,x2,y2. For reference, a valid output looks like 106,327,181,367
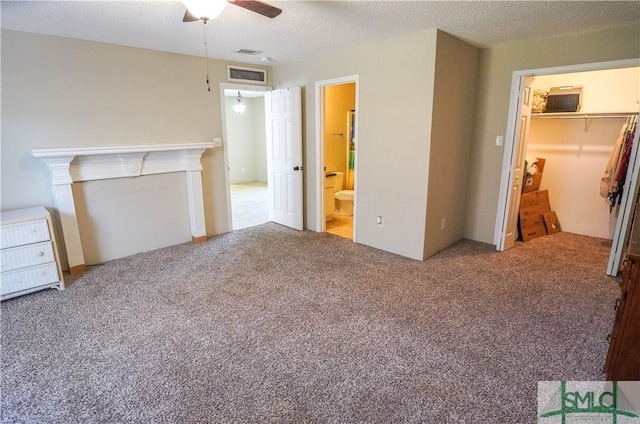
423,32,479,258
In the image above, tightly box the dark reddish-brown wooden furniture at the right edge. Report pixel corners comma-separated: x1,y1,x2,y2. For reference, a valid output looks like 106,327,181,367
604,254,640,381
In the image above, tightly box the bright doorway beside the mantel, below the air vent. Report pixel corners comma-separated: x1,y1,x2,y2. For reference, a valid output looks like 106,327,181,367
221,83,269,230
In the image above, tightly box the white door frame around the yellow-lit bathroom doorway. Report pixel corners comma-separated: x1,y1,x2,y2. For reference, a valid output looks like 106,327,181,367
315,74,360,238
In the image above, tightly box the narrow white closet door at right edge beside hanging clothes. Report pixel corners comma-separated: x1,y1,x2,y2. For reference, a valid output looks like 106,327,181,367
607,116,640,277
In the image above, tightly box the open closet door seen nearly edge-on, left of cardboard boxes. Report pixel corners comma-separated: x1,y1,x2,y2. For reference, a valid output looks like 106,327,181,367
497,76,534,250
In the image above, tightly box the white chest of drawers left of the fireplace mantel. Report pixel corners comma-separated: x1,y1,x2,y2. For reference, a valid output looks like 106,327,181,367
0,207,64,300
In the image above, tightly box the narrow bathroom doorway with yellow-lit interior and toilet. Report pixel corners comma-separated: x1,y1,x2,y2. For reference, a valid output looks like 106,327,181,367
316,76,358,241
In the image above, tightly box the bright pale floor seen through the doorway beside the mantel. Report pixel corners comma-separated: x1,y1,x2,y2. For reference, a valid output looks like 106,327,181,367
229,181,269,230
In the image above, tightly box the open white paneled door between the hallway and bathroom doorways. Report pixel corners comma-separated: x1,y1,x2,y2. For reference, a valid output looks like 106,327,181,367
265,87,303,230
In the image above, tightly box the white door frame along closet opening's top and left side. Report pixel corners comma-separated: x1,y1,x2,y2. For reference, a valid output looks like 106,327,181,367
493,58,640,272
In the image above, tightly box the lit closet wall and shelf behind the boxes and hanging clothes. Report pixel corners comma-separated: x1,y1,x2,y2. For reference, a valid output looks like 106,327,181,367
526,67,640,240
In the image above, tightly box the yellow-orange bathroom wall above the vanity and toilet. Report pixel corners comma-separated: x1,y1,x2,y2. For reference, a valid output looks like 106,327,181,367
324,83,356,175
